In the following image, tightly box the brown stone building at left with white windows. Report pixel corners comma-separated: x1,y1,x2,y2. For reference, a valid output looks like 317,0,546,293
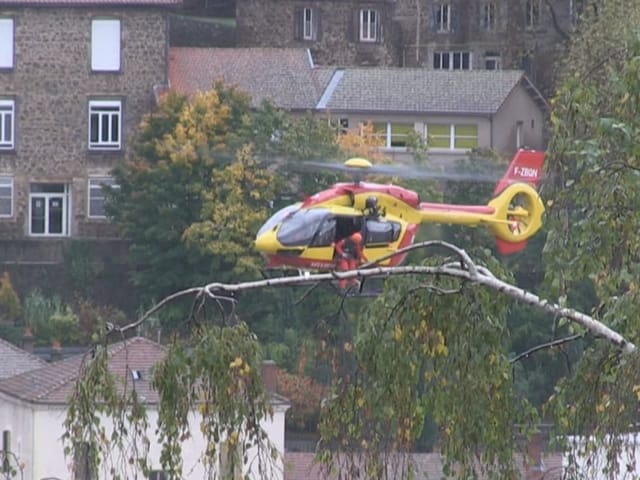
0,0,181,263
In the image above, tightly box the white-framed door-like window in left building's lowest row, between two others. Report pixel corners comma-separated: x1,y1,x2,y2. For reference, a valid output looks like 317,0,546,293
29,183,70,236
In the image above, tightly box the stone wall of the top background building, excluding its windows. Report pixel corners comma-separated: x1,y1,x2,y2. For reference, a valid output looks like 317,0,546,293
236,0,573,94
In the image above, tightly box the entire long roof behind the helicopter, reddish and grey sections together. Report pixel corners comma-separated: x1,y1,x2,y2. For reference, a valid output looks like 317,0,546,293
169,48,548,115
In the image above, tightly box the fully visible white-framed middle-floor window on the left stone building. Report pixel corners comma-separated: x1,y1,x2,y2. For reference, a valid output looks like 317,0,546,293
89,100,122,150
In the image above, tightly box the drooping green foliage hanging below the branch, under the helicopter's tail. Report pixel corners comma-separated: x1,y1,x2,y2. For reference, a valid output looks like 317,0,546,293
320,253,538,478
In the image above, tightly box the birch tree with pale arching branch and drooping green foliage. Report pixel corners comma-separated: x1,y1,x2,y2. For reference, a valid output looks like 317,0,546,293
69,11,640,478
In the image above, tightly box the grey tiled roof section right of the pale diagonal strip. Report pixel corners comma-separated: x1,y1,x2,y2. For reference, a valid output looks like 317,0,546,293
326,67,540,114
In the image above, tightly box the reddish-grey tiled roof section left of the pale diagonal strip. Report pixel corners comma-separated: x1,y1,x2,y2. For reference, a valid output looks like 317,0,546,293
169,47,320,110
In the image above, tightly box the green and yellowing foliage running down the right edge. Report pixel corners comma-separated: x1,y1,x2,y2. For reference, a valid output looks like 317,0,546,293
544,0,640,477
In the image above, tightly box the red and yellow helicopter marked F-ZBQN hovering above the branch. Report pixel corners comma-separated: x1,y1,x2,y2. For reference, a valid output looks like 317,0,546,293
255,149,544,271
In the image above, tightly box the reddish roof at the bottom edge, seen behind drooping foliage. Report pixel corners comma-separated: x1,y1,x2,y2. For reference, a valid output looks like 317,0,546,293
284,452,562,480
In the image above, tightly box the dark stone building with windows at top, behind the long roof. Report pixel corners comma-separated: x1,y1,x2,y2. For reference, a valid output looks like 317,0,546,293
236,0,584,92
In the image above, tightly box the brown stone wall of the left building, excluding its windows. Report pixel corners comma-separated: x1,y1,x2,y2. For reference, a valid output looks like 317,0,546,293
0,7,168,238
